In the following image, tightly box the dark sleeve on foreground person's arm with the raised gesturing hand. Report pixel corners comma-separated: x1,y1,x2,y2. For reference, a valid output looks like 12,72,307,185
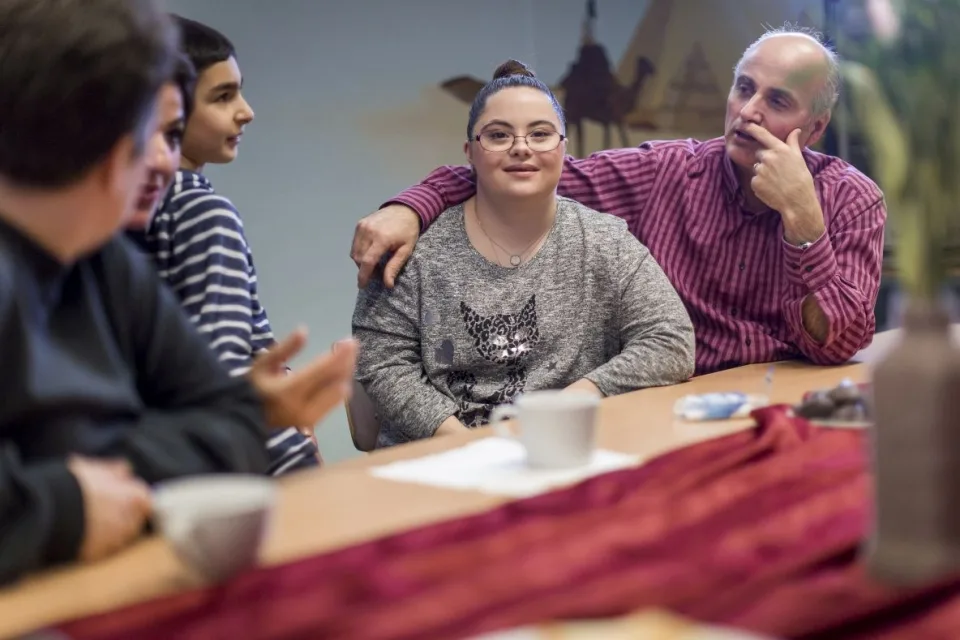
101,239,269,483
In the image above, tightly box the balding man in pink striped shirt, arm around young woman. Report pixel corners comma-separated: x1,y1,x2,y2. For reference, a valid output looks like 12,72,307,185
351,30,886,374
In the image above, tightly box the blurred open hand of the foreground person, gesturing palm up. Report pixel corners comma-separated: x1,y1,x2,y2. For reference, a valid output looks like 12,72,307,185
248,329,357,437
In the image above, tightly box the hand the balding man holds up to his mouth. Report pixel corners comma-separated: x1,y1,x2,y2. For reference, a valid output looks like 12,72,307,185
745,123,825,245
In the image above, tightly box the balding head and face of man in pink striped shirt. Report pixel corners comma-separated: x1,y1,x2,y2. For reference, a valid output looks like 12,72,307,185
724,34,830,170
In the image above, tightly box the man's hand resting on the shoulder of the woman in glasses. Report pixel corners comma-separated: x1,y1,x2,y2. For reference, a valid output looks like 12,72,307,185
350,204,420,289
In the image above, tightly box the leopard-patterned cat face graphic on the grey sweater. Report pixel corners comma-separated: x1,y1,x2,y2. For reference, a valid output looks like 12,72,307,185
460,295,540,365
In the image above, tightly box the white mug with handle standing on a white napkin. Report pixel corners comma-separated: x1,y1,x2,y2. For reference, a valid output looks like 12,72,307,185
490,391,600,469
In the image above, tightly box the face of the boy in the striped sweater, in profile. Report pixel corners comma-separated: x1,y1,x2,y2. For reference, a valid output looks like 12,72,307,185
183,57,254,166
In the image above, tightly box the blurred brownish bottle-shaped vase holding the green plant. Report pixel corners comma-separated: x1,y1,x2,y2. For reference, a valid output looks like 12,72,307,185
868,301,960,584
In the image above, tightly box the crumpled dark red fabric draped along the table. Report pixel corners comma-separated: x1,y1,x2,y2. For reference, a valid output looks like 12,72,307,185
63,408,960,640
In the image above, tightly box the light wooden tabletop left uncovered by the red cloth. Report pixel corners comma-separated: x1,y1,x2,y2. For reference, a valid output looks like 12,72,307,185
0,362,869,638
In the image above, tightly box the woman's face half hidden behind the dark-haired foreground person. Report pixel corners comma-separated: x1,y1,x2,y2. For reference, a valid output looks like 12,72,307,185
127,82,184,229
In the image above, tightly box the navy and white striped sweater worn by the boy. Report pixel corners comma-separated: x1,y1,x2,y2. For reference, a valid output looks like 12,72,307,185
130,169,318,475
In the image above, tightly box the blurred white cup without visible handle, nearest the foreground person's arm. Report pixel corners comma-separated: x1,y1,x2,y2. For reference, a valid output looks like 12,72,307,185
153,474,276,581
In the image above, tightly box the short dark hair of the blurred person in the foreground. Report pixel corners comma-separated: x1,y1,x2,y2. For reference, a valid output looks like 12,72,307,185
0,0,177,189
